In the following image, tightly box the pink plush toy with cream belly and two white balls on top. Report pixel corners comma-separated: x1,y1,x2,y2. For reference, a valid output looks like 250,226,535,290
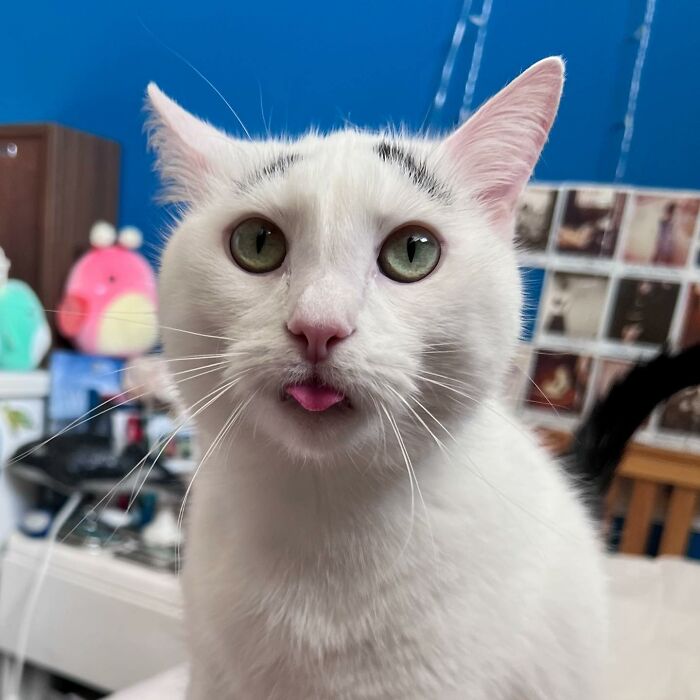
58,221,158,357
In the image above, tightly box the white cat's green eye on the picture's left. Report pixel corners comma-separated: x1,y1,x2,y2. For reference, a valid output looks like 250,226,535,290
229,219,287,273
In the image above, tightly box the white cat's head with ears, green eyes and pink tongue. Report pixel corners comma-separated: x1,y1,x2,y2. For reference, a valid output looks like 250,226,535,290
148,58,563,461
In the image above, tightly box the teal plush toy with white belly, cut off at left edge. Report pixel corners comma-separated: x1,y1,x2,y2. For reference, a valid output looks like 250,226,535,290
0,248,51,372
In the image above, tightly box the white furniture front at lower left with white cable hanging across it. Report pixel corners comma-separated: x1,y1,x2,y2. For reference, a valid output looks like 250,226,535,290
0,534,185,691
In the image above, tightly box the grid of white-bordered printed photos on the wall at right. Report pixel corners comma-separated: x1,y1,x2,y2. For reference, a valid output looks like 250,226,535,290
509,184,700,452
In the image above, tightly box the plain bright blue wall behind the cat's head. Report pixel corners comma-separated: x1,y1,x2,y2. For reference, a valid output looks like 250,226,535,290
0,0,700,254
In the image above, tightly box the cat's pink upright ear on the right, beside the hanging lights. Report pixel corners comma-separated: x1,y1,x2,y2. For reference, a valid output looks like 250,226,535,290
440,56,564,224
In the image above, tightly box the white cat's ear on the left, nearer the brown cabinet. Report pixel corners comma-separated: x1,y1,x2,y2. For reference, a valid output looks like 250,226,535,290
146,83,240,203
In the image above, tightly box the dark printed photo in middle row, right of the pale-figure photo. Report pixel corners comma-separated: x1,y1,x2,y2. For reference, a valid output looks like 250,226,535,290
608,279,679,345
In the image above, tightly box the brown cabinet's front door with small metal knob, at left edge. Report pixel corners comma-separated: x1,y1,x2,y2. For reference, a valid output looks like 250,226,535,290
0,135,45,289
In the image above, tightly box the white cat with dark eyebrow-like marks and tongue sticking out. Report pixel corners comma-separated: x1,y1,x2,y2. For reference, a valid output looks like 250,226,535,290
149,58,606,700
